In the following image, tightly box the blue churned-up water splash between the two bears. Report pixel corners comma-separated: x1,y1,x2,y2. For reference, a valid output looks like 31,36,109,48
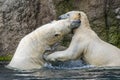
44,60,94,69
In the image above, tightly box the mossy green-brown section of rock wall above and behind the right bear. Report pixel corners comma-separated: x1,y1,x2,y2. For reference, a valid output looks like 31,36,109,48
54,0,120,48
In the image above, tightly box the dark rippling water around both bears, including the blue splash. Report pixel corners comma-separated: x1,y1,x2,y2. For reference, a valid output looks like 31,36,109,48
0,61,120,80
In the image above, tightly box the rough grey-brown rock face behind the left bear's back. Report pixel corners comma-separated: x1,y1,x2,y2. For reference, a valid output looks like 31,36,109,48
0,0,56,54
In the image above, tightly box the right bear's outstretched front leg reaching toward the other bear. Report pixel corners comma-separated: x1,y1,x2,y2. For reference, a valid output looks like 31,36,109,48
45,37,84,61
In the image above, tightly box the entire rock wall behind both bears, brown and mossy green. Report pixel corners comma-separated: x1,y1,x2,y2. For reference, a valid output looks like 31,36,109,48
0,0,120,55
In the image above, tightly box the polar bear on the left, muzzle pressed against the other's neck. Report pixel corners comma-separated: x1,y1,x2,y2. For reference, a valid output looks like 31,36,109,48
7,18,80,70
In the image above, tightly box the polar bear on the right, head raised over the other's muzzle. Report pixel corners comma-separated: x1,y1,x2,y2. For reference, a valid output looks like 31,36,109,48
45,11,120,67
